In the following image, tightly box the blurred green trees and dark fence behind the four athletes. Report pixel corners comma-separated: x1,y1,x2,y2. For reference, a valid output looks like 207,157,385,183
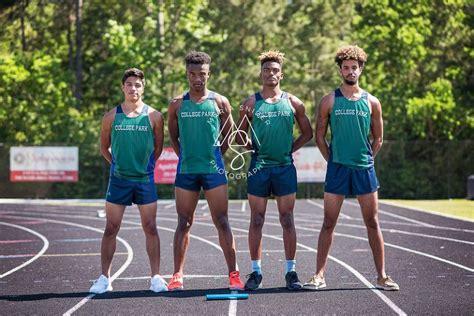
0,0,474,198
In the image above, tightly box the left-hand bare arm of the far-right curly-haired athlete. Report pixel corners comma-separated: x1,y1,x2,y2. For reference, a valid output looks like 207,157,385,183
314,92,334,161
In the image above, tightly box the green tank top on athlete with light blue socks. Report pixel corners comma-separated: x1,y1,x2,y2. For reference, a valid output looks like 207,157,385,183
251,92,294,168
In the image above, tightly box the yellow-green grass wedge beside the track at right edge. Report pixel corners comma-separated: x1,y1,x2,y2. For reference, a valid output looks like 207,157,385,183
380,199,474,220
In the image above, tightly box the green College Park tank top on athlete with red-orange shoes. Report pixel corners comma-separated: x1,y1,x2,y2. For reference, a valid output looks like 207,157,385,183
177,91,225,174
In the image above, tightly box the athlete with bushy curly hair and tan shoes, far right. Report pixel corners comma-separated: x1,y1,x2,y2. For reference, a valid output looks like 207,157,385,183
304,46,399,291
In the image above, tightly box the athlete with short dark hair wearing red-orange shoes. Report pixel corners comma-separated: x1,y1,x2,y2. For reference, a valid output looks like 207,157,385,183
168,52,244,291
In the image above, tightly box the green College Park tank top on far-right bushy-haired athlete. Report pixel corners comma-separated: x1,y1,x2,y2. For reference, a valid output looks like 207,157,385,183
329,89,374,169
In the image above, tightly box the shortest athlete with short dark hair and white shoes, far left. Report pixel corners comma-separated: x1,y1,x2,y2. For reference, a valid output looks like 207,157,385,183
89,68,167,294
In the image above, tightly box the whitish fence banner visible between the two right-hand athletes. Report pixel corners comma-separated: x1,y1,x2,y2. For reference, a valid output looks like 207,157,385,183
293,147,327,183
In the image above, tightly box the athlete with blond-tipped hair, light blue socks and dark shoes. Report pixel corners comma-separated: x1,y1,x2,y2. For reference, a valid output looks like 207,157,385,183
237,51,313,290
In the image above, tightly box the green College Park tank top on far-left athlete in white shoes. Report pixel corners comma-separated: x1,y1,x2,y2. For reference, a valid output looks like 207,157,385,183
110,104,155,182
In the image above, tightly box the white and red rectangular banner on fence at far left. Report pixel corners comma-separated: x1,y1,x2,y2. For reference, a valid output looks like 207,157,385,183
10,146,79,182
